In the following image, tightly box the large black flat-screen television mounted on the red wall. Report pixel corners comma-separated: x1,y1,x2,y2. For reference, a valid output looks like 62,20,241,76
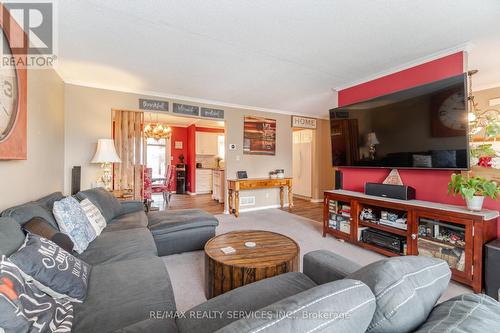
330,74,469,170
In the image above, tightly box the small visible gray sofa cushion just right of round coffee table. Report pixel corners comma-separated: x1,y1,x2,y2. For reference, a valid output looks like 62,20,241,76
303,250,362,284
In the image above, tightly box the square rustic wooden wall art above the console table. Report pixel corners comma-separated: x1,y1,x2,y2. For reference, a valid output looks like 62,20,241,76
243,117,276,155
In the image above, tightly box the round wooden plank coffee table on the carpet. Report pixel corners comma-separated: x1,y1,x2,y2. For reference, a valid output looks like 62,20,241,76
205,230,300,299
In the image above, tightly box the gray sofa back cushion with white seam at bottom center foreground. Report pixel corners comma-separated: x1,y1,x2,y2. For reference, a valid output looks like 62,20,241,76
217,279,375,333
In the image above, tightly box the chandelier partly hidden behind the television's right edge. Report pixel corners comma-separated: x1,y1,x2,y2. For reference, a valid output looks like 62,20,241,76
467,70,500,140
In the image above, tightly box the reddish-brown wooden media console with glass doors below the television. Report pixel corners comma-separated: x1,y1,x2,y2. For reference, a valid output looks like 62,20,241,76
323,190,499,293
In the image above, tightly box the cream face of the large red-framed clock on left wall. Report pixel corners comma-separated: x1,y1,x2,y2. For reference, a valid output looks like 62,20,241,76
0,29,18,142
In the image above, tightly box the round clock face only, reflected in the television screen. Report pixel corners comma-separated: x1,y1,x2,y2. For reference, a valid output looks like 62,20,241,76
438,91,467,131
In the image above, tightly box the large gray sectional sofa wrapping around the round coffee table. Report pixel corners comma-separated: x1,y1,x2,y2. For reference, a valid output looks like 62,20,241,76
0,190,500,333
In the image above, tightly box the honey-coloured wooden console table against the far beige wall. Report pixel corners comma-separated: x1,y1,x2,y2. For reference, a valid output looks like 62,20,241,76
227,178,293,217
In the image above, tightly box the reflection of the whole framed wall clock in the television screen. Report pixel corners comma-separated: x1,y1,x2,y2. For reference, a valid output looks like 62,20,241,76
431,89,467,137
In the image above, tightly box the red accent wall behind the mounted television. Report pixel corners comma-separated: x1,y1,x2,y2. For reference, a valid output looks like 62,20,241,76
338,52,500,236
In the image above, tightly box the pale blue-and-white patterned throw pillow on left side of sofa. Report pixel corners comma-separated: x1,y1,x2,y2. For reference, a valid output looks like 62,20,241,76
54,197,97,253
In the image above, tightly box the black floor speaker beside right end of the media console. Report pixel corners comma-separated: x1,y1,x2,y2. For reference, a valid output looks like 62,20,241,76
484,238,500,301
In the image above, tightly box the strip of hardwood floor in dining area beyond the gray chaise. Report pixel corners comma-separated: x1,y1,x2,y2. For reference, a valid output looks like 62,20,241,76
153,194,224,215
